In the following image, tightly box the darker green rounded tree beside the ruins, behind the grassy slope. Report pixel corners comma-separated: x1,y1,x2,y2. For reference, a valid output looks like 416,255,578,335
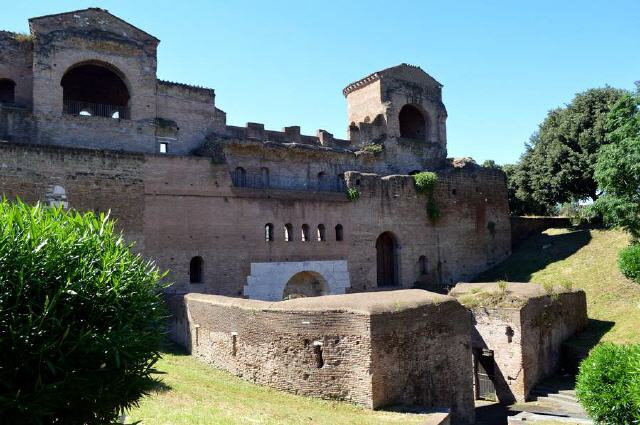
511,87,627,212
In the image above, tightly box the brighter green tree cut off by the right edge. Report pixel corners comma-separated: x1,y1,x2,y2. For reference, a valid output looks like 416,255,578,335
594,88,640,242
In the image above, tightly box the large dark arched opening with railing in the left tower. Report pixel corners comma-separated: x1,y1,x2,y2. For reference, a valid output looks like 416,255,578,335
60,63,130,119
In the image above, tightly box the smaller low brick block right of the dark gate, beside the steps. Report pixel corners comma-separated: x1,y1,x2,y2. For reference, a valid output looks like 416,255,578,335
451,283,587,403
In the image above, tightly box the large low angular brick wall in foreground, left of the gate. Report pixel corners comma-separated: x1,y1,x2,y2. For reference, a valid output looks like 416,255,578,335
173,290,474,423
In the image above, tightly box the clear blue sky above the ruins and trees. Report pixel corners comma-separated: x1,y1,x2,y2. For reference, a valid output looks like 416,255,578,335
0,0,640,163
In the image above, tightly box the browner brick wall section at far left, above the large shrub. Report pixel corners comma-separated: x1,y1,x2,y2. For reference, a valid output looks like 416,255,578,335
0,143,145,245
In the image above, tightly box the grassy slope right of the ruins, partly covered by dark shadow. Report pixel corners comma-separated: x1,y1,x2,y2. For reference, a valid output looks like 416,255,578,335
476,229,640,348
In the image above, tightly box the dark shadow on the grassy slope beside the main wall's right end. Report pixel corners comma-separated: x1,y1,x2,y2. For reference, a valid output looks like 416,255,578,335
473,228,591,282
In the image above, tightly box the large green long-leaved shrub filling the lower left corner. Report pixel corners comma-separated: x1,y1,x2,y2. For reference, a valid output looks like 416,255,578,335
0,200,166,425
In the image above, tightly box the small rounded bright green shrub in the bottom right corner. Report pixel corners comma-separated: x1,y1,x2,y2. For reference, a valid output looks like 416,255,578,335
576,343,640,424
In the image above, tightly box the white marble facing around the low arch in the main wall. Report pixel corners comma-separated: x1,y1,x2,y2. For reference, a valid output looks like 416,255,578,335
244,260,351,301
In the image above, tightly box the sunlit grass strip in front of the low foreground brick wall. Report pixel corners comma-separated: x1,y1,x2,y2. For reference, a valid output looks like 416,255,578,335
127,353,427,425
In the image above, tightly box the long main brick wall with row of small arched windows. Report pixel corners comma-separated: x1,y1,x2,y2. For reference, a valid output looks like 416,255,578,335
0,144,510,296
